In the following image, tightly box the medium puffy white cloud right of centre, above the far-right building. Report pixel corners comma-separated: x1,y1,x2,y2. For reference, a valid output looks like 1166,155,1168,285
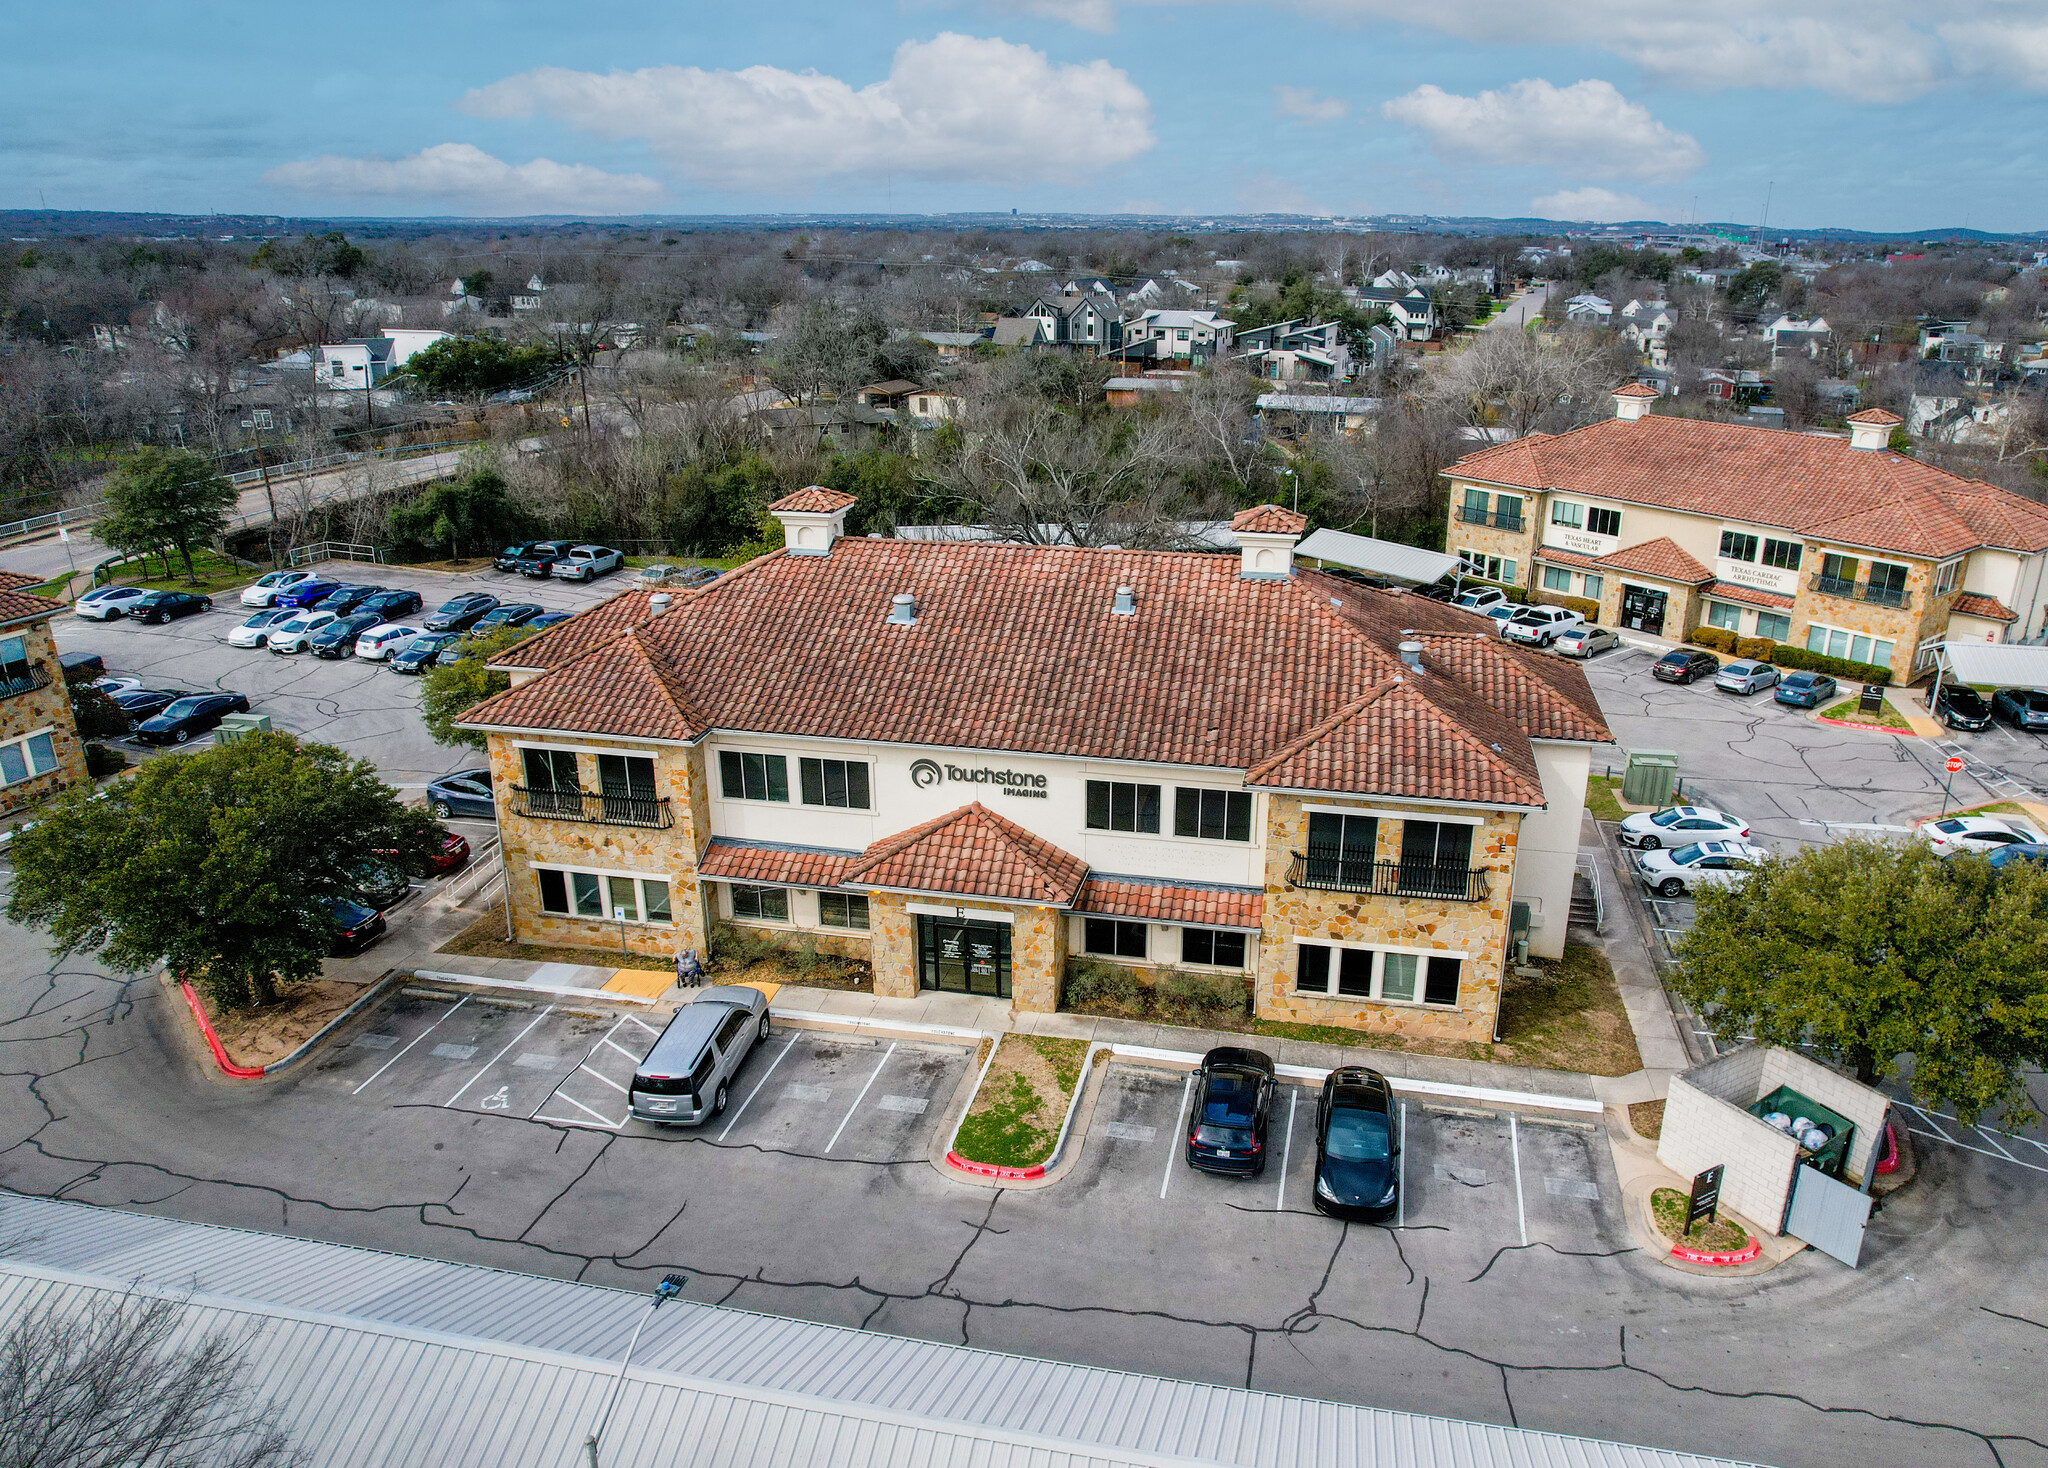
1380,78,1706,182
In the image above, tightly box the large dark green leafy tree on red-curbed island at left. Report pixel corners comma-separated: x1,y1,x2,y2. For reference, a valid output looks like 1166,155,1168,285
8,733,436,1007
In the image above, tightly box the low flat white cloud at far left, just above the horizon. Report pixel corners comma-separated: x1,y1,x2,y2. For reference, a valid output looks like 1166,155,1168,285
262,143,664,215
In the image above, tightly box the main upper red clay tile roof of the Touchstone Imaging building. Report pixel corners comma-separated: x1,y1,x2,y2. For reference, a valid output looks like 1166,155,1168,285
465,538,1610,801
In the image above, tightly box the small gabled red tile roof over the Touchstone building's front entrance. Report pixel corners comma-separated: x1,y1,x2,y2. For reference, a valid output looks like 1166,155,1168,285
840,801,1087,907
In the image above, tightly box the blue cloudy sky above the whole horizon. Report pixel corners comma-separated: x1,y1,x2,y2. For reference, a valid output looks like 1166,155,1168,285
16,0,2048,229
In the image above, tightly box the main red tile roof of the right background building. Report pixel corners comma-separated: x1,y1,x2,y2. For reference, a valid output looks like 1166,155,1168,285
1444,414,2048,557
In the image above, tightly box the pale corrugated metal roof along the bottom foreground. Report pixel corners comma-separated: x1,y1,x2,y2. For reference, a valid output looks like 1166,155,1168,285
0,1196,1761,1468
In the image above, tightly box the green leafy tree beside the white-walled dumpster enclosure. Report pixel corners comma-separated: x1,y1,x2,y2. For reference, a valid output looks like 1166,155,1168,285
1671,839,2048,1122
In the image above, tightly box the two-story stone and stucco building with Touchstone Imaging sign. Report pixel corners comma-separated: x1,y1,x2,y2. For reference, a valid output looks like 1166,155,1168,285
463,487,1610,1040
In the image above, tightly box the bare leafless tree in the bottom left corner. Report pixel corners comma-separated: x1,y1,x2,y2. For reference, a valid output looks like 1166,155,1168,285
0,1288,301,1468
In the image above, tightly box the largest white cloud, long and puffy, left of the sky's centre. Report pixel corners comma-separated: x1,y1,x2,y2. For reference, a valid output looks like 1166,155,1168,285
463,33,1153,192
